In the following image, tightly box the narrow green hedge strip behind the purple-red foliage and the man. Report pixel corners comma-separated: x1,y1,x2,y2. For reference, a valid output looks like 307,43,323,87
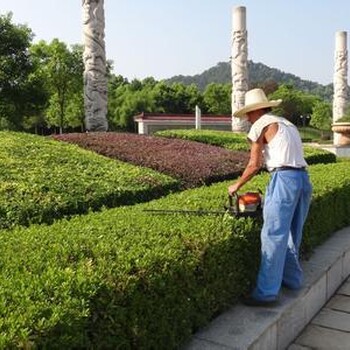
155,129,336,165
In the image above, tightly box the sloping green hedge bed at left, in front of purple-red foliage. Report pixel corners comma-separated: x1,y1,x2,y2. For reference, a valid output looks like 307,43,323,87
0,132,179,228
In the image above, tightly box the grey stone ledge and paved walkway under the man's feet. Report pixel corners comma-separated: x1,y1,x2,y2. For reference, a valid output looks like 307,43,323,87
183,227,350,350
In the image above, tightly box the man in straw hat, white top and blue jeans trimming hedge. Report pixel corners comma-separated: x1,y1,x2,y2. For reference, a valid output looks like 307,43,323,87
228,89,312,306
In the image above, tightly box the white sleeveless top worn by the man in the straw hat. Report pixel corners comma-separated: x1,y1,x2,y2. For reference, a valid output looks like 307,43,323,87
248,114,307,171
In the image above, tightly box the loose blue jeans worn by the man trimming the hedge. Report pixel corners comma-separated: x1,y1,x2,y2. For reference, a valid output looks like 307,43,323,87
252,170,312,301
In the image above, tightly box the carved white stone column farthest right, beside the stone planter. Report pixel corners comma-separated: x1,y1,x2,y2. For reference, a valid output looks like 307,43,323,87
333,31,348,145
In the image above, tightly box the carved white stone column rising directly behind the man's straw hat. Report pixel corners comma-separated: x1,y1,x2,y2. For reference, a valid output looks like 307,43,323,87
231,6,248,131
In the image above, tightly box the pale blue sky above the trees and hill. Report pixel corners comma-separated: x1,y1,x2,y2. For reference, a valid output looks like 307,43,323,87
0,0,350,84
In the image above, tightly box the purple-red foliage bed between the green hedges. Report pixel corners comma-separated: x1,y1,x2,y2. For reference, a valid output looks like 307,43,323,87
53,132,249,188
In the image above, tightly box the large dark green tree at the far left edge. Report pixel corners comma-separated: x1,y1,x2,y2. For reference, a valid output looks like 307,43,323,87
0,13,46,130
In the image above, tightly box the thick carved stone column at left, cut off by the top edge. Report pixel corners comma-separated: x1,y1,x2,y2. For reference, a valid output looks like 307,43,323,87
82,0,108,131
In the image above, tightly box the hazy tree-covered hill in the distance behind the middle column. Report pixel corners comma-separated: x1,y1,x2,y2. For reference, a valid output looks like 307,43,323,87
166,61,333,101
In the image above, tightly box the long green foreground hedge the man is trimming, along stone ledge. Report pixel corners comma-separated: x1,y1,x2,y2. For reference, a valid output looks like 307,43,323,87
0,162,350,349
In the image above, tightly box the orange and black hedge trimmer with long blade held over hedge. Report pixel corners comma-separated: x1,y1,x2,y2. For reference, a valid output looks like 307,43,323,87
143,191,263,217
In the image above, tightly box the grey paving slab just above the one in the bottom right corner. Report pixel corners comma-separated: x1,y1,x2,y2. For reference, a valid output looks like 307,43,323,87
312,308,350,332
